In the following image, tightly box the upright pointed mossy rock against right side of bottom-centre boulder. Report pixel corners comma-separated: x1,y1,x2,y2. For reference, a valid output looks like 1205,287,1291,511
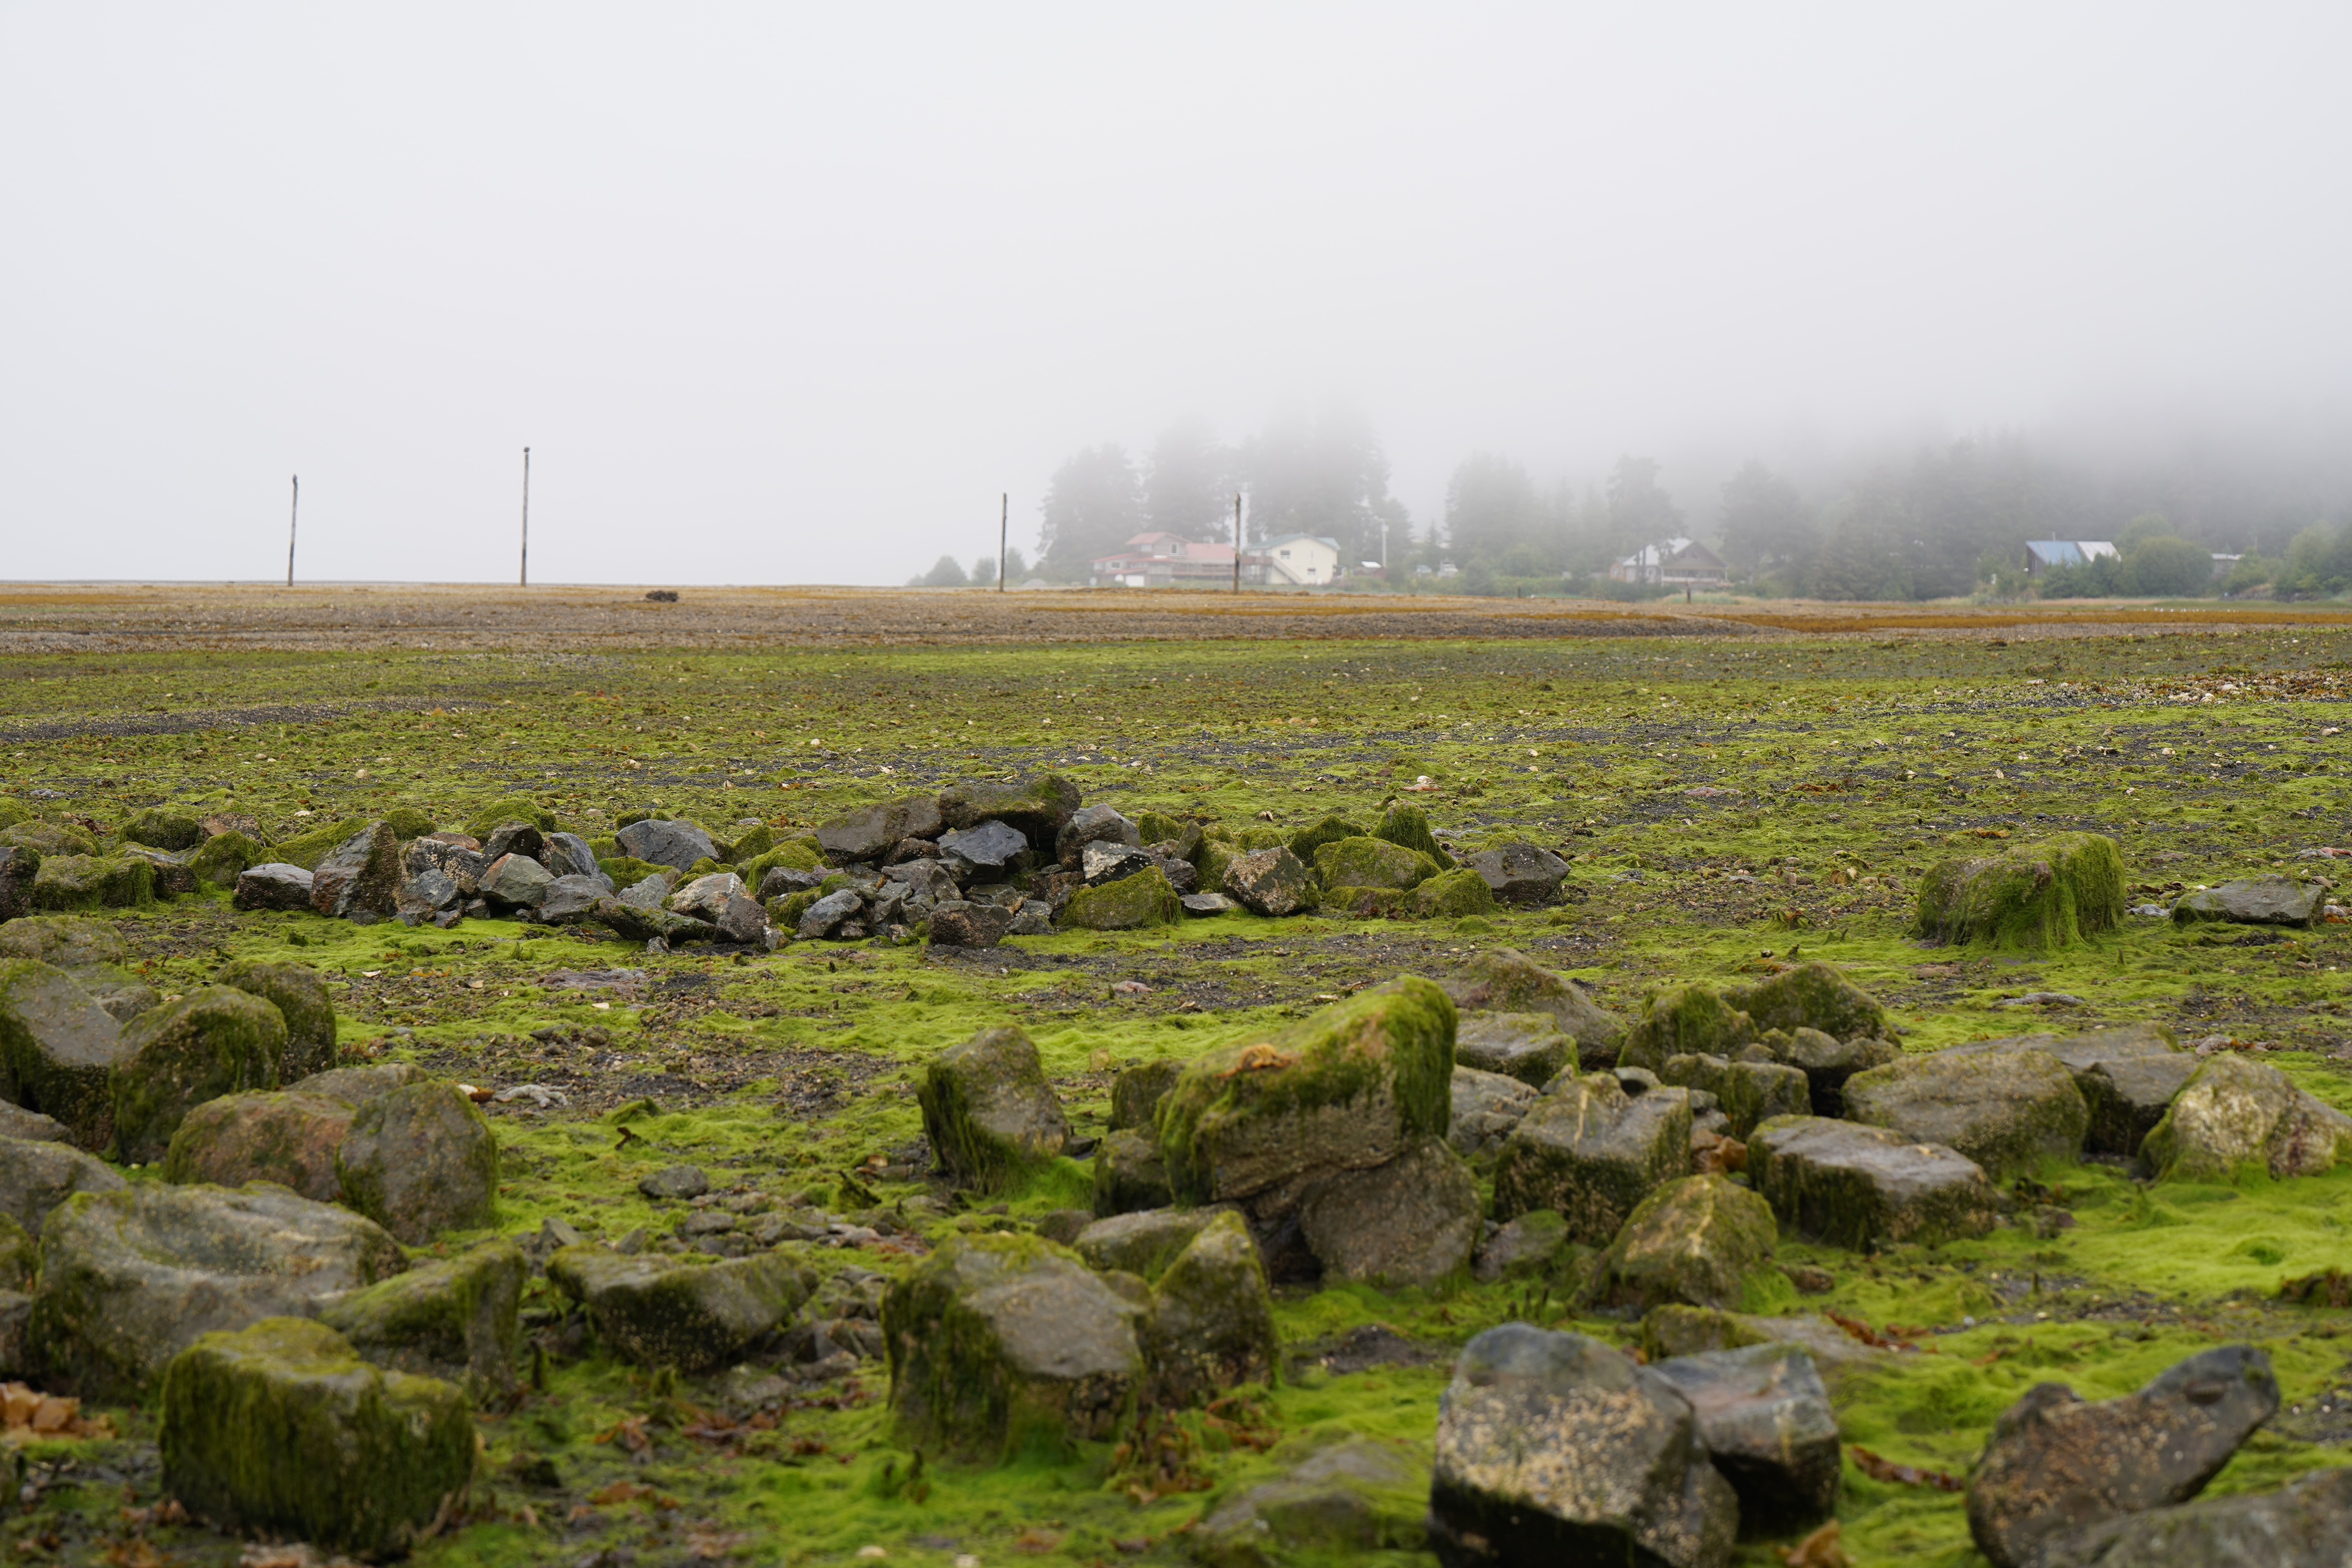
1143,1210,1282,1406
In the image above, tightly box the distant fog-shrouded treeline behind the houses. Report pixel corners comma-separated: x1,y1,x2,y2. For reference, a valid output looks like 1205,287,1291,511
1035,409,2352,599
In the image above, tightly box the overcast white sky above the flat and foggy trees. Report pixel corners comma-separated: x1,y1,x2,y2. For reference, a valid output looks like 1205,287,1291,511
0,0,2352,583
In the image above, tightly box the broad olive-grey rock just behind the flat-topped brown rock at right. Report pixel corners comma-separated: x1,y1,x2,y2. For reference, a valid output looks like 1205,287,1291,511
1844,1049,2091,1180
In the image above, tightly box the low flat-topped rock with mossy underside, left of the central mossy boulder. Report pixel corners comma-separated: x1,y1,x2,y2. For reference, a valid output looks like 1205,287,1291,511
548,1246,816,1373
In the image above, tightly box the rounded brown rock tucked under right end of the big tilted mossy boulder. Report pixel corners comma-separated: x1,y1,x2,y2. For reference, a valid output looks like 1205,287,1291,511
1298,1138,1479,1290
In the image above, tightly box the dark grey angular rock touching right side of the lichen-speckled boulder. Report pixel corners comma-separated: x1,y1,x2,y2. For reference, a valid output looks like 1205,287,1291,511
1656,1345,1844,1535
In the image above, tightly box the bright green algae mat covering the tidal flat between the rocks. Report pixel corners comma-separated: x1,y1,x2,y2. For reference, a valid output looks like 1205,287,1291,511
0,625,2352,1568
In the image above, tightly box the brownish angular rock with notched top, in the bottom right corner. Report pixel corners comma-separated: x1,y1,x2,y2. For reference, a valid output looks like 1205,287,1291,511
1969,1345,2279,1568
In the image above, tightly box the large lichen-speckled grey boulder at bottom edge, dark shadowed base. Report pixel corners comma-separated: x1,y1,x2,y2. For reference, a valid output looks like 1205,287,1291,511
1430,1323,1738,1568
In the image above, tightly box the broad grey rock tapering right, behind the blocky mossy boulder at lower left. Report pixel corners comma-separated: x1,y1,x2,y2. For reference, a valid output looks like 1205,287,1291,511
28,1182,407,1396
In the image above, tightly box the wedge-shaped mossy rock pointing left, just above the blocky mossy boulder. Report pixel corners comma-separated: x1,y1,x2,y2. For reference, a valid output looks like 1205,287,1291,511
318,1241,532,1406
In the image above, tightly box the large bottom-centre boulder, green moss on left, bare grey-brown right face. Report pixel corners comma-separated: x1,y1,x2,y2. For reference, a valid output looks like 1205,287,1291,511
882,1234,1150,1462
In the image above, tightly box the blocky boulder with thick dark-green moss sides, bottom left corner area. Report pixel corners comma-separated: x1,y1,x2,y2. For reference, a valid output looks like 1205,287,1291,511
155,1316,473,1556
